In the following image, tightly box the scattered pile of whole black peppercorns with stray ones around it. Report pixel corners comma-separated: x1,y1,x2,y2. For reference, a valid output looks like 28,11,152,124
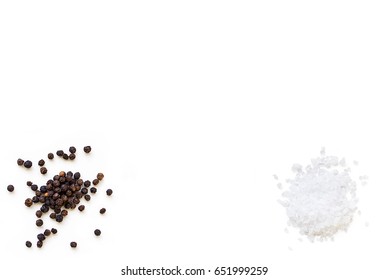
7,146,113,248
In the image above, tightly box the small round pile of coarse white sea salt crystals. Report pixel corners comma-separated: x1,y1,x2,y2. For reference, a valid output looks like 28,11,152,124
275,149,358,241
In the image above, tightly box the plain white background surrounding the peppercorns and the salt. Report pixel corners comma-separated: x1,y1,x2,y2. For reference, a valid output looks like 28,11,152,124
0,0,389,280
